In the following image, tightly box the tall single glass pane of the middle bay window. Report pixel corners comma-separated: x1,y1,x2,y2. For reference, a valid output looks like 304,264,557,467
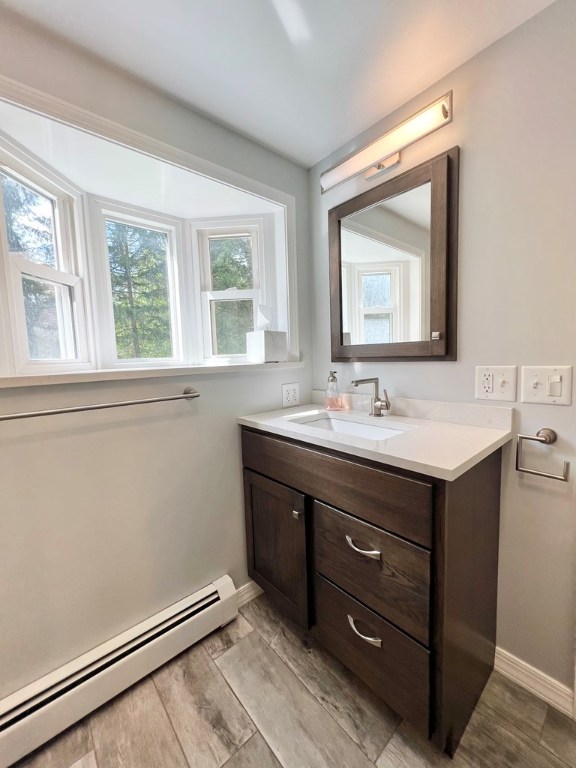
106,219,173,360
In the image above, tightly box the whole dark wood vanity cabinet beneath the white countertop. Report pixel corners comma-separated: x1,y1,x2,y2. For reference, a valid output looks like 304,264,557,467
242,427,500,754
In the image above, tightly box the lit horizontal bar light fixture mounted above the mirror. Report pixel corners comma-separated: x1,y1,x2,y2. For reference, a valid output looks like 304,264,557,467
320,91,452,192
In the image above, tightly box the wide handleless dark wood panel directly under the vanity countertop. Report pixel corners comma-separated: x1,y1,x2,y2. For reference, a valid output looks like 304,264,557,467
242,429,434,548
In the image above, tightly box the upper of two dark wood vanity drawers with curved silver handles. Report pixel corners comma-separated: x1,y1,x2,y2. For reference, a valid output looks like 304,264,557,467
314,502,430,645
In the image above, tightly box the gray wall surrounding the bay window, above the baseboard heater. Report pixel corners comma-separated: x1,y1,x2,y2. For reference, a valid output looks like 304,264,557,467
0,12,311,697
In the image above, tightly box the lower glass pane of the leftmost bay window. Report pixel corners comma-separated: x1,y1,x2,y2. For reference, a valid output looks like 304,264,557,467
22,275,77,360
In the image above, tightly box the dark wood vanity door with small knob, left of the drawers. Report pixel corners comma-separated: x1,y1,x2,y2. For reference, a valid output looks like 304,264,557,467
244,469,309,628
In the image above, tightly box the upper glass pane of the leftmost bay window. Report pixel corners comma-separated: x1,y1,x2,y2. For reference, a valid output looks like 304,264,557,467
0,173,57,267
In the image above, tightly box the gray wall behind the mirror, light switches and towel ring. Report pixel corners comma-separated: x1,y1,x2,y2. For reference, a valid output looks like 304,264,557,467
310,0,576,687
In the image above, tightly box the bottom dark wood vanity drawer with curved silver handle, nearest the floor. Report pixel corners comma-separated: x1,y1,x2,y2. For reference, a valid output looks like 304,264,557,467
316,576,429,736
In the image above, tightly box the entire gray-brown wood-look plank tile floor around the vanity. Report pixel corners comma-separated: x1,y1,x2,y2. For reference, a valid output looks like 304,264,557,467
12,596,576,768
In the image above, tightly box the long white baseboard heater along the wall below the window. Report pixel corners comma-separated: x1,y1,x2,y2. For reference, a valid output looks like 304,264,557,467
0,576,238,768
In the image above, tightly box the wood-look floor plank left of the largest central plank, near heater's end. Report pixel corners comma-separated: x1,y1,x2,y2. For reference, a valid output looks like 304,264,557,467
152,644,256,768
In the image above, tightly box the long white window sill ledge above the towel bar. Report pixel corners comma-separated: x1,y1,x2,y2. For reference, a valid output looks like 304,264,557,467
0,360,304,389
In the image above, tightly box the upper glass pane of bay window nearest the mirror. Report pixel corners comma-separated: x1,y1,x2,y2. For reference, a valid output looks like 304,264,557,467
208,235,254,291
